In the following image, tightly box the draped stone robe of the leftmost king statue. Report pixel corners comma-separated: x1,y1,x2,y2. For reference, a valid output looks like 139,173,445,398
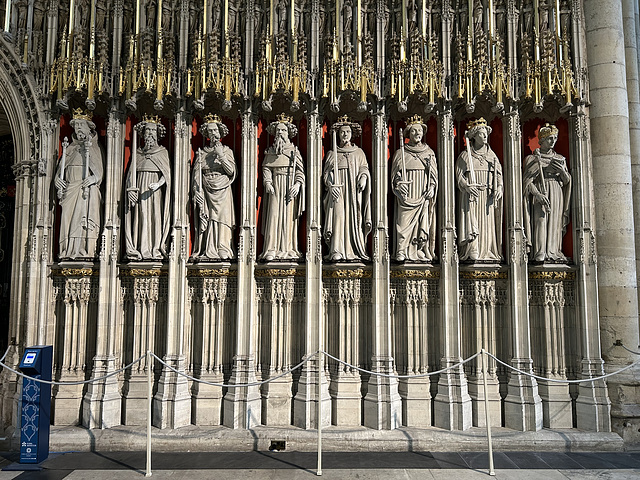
56,131,104,259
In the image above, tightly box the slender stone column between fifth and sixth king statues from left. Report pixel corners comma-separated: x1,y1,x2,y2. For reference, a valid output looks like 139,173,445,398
364,104,402,430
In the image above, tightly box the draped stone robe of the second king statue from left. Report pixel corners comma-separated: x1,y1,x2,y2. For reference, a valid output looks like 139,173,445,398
125,145,171,260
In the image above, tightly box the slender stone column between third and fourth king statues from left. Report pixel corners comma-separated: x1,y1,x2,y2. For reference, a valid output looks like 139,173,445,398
222,106,262,428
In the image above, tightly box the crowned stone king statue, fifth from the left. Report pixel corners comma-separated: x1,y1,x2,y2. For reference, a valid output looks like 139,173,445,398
322,115,371,262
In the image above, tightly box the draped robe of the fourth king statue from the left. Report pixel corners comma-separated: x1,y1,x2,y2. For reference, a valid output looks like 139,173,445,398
260,143,305,260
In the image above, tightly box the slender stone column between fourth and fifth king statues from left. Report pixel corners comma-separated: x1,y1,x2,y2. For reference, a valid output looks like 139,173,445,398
293,104,331,429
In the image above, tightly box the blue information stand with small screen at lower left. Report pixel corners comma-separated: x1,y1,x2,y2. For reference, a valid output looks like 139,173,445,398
20,346,53,463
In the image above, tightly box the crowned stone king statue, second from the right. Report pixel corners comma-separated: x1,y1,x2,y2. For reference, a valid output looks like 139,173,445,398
455,118,504,262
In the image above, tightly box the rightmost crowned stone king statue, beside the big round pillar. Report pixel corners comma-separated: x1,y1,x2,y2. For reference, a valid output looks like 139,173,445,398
522,124,571,262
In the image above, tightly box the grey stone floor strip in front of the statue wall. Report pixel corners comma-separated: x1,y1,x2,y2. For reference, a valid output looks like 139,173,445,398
0,451,640,480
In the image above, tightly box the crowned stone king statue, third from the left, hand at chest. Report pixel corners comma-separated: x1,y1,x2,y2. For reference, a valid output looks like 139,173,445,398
191,115,237,260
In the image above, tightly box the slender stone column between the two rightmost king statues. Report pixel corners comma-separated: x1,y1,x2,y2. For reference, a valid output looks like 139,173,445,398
502,110,542,431
